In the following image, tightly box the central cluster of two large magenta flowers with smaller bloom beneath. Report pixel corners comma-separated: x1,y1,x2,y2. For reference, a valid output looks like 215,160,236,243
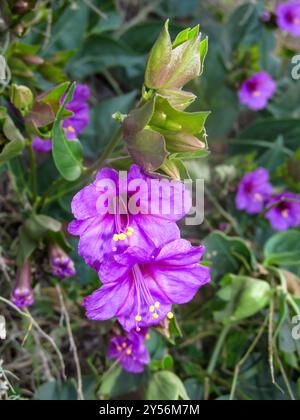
69,165,210,371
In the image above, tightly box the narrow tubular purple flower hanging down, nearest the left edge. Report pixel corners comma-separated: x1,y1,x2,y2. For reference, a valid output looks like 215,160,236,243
11,261,34,309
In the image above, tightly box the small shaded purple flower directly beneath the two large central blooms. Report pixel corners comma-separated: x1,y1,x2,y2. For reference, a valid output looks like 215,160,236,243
108,330,150,373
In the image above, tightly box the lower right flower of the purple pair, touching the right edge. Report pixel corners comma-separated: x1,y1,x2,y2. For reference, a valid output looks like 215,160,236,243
266,192,300,231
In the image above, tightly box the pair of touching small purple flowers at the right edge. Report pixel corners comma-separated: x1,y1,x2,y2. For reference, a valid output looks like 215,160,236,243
236,168,300,231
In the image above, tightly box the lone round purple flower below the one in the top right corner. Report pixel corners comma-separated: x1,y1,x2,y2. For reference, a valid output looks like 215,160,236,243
239,71,276,111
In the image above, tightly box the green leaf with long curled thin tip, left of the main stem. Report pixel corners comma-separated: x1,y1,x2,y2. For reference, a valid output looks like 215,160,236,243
52,83,82,182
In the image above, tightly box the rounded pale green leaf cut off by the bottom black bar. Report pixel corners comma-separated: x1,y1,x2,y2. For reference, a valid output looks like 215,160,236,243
145,371,189,401
